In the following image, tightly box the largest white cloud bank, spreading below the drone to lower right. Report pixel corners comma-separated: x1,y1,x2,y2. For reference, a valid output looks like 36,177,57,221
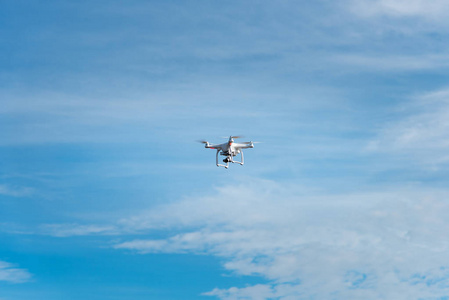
115,181,449,299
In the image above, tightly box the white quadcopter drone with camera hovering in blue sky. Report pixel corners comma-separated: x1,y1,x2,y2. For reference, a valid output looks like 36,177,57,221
199,135,257,169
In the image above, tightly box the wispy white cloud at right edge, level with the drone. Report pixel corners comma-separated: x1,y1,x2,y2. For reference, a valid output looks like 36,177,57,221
368,89,449,167
